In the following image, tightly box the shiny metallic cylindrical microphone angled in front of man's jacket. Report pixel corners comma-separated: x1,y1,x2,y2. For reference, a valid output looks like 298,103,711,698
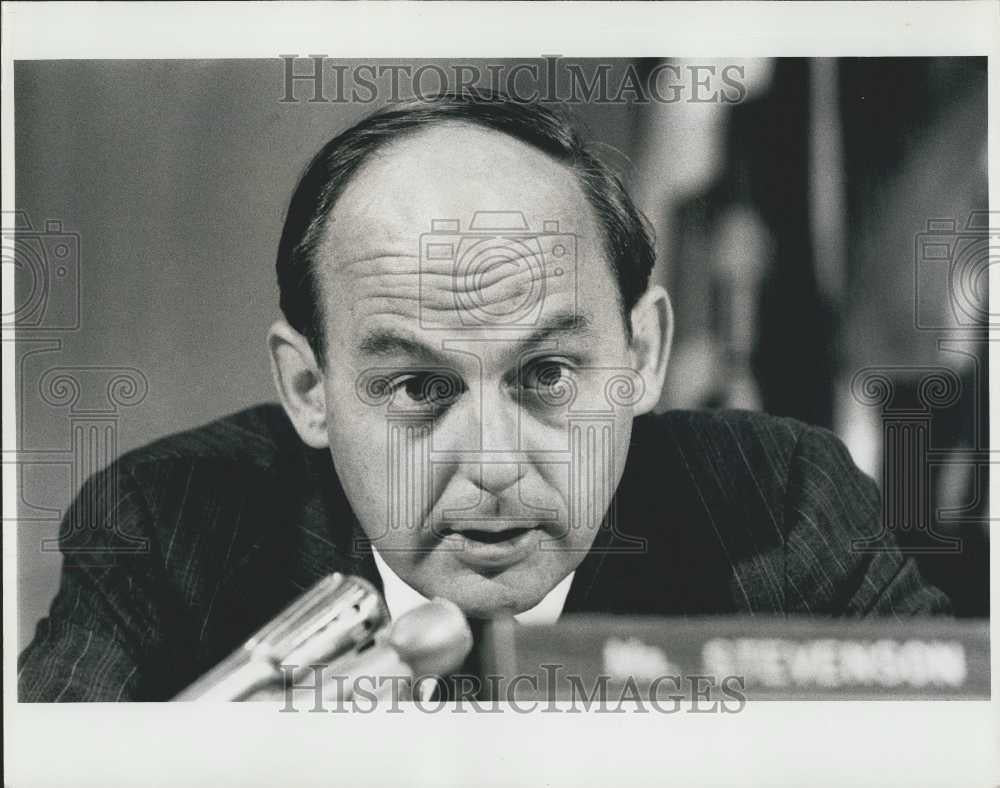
174,572,389,701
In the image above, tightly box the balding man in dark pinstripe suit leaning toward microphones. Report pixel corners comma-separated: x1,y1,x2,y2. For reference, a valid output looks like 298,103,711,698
20,95,948,700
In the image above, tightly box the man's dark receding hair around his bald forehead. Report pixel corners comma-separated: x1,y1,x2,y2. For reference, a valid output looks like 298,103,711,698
277,91,655,361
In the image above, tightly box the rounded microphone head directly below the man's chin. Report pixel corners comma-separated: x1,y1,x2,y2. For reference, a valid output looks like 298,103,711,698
389,597,472,677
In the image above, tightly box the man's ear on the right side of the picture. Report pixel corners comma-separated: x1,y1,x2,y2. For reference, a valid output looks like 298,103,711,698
631,285,674,416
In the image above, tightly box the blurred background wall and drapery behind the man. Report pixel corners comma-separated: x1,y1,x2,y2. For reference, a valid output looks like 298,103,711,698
11,57,997,647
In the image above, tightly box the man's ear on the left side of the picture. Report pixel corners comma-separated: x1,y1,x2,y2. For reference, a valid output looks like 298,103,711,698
267,320,330,449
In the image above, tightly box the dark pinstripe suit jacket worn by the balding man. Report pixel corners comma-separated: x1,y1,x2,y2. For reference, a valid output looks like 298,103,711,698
19,405,948,701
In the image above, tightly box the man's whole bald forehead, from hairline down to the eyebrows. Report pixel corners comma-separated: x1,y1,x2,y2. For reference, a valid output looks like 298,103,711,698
317,124,617,350
